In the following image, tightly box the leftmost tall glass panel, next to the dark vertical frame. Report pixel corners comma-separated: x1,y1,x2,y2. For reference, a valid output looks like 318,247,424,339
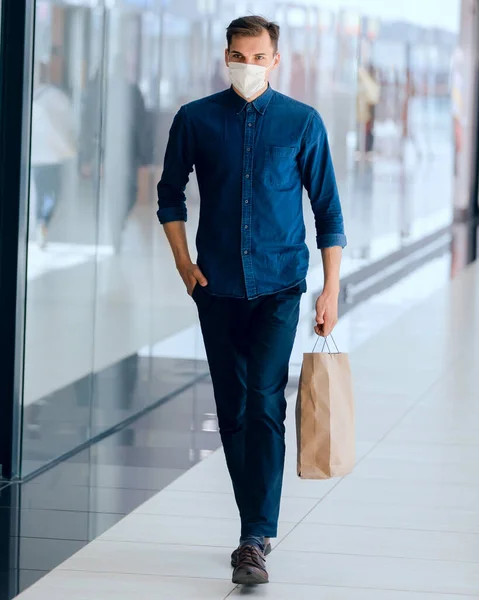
23,0,103,475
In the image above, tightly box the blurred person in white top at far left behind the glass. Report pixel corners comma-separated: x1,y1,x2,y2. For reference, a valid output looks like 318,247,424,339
31,63,77,248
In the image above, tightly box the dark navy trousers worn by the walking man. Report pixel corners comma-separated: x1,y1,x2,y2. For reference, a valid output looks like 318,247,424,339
193,281,306,538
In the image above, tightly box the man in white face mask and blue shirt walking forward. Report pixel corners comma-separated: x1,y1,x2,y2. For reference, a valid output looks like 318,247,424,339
158,17,346,584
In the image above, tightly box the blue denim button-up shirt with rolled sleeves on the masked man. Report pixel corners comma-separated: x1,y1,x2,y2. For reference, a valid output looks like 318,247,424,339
157,87,346,299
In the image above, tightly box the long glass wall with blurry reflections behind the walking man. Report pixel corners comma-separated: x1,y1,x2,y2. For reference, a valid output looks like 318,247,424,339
23,0,464,475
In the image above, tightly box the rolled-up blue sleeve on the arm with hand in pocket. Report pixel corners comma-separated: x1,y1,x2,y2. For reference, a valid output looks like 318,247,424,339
156,106,194,225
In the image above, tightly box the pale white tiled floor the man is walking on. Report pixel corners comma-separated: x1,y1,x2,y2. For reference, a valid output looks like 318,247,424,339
9,266,479,600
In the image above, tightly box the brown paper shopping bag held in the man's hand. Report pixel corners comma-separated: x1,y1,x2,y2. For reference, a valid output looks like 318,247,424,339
296,340,356,479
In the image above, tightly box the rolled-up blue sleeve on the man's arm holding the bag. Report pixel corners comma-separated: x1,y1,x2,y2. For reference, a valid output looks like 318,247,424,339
299,112,347,249
